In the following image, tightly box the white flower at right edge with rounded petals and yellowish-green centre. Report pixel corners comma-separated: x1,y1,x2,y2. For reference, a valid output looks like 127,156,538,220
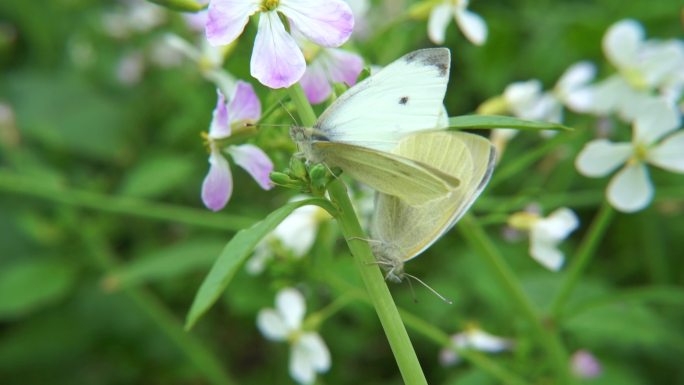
575,99,684,212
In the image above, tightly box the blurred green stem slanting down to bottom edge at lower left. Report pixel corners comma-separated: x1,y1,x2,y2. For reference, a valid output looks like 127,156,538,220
80,218,235,385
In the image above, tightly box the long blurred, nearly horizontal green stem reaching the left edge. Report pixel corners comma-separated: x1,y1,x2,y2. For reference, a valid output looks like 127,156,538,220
0,170,254,231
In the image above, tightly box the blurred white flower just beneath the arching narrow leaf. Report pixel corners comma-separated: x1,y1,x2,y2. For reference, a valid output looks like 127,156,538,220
245,196,330,275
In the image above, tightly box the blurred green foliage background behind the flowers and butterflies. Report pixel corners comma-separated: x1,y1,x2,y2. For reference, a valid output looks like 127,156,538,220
0,0,684,385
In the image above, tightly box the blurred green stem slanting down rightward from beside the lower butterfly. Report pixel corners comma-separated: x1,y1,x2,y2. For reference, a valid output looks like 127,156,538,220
458,215,574,384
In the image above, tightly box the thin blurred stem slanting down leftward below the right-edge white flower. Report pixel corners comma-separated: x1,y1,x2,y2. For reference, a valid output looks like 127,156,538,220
551,201,615,319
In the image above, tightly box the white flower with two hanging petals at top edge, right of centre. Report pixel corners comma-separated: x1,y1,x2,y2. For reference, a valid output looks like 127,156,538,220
428,0,487,45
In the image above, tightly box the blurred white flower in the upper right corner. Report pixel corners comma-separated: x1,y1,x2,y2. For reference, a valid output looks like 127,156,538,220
590,19,684,122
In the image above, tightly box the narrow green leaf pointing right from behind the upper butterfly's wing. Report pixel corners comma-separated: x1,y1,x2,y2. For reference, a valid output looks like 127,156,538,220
448,115,573,131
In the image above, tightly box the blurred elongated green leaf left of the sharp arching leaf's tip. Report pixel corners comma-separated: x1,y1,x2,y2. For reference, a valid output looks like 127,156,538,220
104,238,225,290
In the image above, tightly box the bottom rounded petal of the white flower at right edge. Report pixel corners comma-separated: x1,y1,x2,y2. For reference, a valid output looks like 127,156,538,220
607,164,653,213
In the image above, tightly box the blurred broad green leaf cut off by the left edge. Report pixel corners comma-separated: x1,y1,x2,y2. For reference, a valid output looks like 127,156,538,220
0,259,76,319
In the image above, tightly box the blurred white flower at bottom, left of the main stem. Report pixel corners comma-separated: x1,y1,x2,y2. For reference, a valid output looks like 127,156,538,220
257,288,331,384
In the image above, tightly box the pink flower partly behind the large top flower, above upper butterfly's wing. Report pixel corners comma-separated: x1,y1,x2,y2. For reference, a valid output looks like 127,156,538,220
300,48,363,104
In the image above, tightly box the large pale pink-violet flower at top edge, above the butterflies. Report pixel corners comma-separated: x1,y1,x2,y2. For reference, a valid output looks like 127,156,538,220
206,0,354,88
